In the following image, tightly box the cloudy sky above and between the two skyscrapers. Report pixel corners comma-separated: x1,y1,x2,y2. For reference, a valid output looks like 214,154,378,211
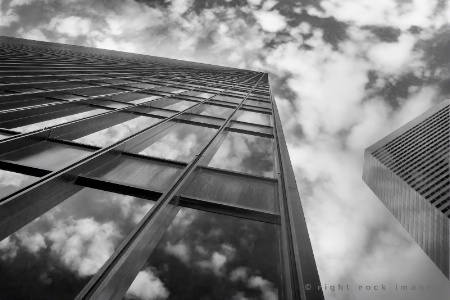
0,0,450,299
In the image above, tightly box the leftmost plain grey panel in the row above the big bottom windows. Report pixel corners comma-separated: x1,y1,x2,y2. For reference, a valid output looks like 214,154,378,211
0,141,92,170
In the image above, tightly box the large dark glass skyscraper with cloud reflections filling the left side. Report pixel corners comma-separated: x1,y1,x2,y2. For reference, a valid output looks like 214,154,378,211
0,37,323,299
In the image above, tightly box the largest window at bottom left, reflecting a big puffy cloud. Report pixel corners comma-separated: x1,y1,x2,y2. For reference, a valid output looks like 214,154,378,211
0,188,153,299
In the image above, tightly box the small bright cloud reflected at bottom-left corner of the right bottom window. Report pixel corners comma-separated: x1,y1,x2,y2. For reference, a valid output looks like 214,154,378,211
126,269,169,300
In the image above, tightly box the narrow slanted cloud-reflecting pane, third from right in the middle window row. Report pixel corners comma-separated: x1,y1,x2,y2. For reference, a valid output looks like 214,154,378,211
75,116,160,147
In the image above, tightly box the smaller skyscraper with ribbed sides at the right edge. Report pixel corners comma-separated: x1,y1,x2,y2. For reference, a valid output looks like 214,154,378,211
363,100,450,277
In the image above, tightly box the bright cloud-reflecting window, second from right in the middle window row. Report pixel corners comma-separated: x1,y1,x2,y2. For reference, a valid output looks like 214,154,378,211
140,124,217,162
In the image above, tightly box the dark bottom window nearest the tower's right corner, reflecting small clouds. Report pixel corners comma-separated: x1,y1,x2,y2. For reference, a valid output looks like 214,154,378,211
125,208,279,300
